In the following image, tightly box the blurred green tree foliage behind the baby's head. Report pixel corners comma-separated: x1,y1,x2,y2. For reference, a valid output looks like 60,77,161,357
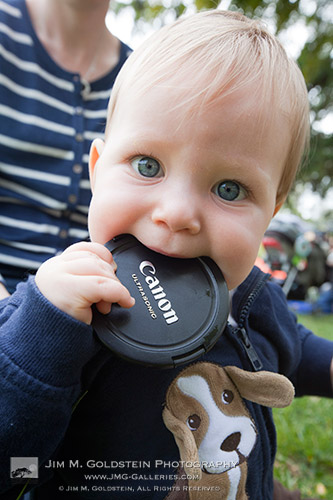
112,0,333,196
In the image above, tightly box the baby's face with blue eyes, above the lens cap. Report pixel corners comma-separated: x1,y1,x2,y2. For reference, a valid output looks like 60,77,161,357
89,82,289,289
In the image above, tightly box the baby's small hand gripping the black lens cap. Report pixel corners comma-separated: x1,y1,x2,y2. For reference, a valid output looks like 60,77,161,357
36,242,135,325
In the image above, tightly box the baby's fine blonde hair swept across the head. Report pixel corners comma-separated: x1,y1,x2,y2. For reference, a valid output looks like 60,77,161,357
106,10,309,203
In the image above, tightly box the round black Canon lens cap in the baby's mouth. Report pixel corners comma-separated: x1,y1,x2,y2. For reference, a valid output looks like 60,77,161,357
92,235,229,368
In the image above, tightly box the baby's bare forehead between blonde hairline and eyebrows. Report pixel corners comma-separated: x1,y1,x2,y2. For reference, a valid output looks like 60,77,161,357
110,79,289,176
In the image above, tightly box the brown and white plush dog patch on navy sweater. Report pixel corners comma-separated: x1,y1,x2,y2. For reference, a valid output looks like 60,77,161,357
163,362,294,500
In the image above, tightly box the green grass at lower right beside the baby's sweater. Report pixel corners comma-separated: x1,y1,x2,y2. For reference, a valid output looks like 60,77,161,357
274,315,333,500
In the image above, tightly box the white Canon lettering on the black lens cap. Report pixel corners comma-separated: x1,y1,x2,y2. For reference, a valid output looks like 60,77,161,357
139,260,178,325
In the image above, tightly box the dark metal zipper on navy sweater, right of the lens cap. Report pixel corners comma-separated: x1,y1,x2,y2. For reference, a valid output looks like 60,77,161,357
232,274,269,372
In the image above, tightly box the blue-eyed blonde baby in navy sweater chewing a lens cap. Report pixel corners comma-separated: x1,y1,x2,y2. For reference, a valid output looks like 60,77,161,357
1,10,333,500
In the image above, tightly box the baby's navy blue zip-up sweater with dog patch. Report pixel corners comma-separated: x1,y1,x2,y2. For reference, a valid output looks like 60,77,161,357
0,268,333,500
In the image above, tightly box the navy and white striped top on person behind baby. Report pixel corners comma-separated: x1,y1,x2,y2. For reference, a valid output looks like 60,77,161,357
0,0,130,289
